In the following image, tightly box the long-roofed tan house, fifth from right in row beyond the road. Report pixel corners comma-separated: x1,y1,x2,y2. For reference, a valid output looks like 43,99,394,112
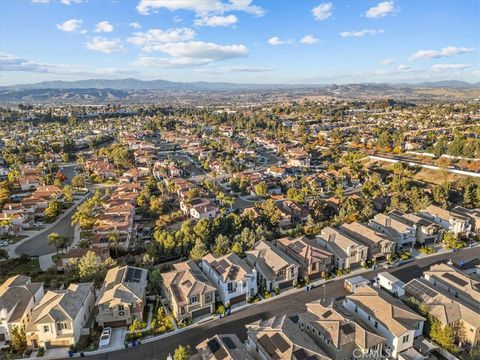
340,221,396,260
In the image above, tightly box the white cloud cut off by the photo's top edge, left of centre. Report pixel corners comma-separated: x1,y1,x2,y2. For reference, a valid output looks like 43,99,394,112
136,0,265,16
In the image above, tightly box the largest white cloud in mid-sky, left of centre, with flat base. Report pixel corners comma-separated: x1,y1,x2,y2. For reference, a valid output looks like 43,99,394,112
135,41,248,67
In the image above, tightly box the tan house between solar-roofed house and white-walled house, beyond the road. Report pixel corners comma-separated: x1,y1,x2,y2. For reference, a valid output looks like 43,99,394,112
162,261,217,321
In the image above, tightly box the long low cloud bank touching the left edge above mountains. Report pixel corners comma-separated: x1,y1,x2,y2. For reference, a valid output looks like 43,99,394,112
0,53,136,77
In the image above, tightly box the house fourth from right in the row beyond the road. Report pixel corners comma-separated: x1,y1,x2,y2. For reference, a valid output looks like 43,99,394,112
368,213,417,251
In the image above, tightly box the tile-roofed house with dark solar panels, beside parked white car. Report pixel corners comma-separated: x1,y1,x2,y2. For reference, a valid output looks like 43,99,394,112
95,266,148,327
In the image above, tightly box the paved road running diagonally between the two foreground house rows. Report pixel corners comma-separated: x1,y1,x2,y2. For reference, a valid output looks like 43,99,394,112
83,247,480,360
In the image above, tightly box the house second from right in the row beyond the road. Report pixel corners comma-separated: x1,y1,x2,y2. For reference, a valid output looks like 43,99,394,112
420,205,472,236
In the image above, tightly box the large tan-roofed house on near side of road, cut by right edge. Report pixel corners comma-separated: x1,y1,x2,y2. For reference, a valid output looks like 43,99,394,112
404,279,480,346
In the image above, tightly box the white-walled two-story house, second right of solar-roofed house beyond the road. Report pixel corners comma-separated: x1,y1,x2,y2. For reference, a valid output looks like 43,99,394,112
201,253,258,305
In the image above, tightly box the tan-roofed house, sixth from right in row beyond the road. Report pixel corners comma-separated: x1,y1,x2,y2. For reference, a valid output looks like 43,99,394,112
316,226,368,269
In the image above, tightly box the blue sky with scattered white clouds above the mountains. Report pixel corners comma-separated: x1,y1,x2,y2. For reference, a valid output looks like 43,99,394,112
0,0,480,86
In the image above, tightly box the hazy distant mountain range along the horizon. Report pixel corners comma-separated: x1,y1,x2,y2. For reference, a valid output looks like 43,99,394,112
0,78,480,103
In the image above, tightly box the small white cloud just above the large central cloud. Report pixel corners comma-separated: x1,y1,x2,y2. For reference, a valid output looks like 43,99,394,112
127,28,195,51
